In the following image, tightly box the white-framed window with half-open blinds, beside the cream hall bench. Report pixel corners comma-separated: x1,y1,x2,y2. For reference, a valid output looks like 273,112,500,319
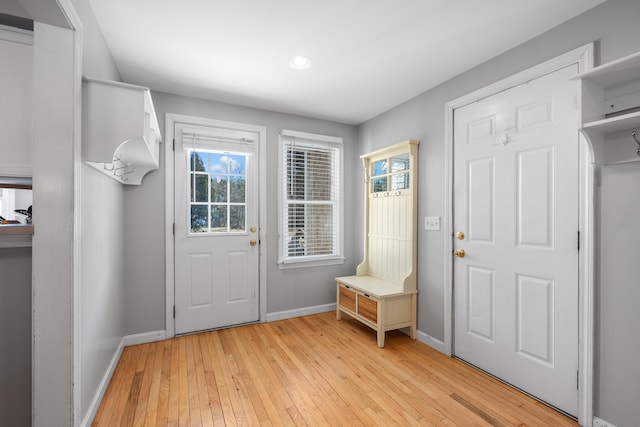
280,130,342,264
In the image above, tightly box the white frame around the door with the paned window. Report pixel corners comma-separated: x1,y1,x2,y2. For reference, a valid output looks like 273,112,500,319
164,113,267,339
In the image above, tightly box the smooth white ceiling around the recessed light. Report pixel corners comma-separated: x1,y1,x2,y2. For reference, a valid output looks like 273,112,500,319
90,0,603,124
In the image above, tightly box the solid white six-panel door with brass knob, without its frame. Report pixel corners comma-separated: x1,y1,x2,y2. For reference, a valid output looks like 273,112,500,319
453,65,579,415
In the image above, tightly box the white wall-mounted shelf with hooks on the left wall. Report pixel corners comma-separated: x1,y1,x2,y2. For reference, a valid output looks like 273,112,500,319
82,77,161,185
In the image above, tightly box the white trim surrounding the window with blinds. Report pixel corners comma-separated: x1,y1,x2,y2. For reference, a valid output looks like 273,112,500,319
277,129,345,270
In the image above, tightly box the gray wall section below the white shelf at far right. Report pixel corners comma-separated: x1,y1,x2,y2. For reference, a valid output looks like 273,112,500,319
595,162,640,427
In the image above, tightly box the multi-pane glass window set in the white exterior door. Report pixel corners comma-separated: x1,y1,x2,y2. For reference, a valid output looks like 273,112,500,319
189,149,247,234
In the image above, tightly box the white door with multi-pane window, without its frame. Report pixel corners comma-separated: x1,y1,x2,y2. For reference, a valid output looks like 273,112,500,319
174,123,259,334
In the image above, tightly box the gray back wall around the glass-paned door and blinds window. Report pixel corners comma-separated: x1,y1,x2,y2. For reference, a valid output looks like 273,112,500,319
125,92,362,334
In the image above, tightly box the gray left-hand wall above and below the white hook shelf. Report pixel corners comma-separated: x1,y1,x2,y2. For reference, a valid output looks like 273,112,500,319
72,0,126,421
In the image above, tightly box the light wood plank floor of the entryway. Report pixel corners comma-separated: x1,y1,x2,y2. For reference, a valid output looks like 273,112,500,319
93,313,577,427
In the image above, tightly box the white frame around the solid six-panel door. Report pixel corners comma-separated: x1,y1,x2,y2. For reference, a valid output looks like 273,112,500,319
440,43,595,427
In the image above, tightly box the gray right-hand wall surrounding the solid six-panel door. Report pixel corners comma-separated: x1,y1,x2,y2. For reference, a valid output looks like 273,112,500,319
360,0,640,427
